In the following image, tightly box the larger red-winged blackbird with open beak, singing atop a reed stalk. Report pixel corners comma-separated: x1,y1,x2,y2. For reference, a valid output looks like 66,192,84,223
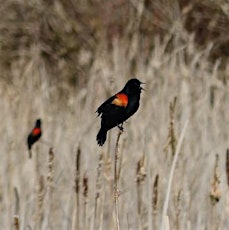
96,78,143,146
